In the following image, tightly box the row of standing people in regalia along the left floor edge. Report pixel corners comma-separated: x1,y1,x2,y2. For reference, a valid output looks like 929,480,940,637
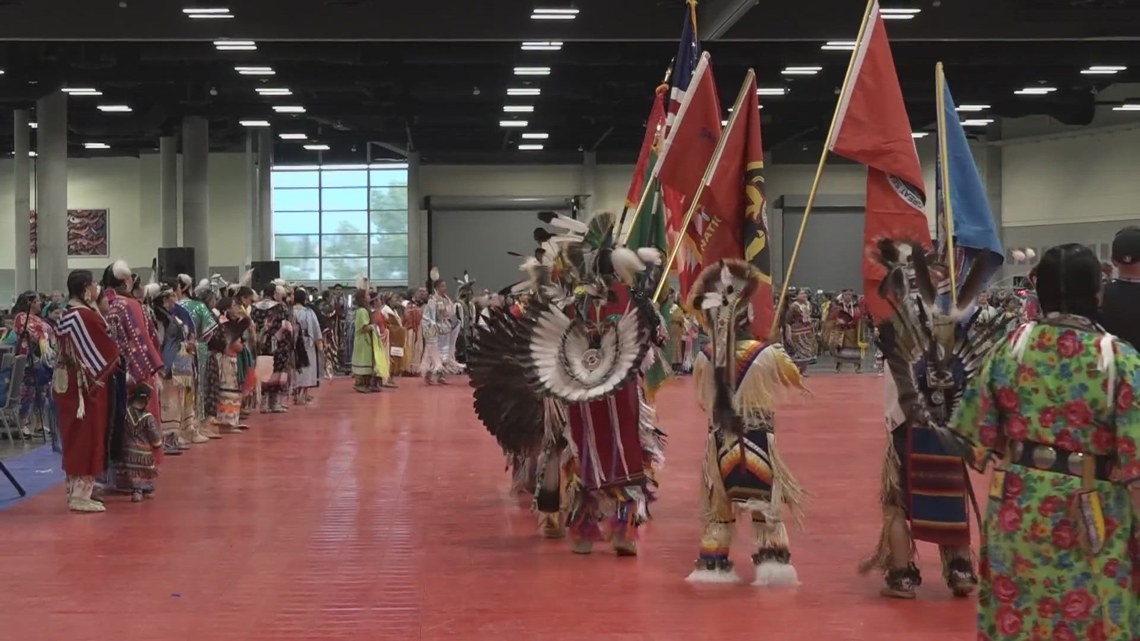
42,261,321,512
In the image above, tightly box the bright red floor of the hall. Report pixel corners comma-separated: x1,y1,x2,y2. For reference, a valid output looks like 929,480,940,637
0,375,975,641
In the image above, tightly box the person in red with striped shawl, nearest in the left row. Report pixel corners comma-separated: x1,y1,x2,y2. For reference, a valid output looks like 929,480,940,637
51,269,119,512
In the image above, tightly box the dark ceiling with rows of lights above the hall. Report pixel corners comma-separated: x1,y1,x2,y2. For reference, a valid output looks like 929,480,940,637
0,0,1140,162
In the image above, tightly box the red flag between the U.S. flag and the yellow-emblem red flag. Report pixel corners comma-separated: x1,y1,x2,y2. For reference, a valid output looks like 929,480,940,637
653,52,722,297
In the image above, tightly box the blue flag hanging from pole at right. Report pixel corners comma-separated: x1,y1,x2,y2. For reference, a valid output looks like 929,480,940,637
935,74,1005,285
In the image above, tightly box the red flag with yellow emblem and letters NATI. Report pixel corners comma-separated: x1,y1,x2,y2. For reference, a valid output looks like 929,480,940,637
694,71,775,340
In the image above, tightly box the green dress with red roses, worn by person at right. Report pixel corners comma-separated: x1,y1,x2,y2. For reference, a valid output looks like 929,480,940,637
952,318,1140,641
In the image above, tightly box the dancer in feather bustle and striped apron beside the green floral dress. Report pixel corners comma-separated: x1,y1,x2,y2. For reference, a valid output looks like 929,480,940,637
860,240,1017,599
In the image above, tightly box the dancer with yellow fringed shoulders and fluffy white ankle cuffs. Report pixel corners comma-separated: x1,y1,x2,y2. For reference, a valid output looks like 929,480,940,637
689,259,804,586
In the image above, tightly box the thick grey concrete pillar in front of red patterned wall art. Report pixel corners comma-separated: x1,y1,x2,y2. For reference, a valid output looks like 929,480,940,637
35,91,68,291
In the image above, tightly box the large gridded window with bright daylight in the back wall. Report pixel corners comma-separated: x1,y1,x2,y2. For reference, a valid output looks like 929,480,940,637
272,164,408,287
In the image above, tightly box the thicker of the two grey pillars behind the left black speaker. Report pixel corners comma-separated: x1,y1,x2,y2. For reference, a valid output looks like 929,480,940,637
182,116,210,281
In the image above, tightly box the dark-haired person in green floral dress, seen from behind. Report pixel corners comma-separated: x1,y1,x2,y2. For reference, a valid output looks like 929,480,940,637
951,243,1140,641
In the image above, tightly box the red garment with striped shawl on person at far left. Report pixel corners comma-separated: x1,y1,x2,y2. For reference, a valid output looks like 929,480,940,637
52,303,119,477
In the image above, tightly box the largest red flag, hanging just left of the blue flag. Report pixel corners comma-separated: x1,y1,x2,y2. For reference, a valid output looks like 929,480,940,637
828,0,930,319
